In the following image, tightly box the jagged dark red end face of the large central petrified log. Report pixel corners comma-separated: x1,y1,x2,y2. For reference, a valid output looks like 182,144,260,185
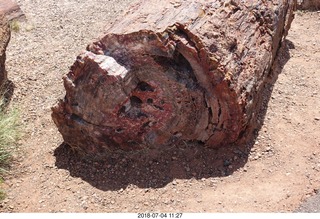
52,20,260,153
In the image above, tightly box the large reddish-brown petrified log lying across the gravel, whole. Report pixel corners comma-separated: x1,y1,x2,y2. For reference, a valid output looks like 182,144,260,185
52,0,296,153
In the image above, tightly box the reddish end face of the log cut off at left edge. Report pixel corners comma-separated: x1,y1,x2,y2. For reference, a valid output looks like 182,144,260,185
0,14,10,88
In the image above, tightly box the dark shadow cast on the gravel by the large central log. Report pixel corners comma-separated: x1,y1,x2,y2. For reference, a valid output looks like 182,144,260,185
54,40,294,191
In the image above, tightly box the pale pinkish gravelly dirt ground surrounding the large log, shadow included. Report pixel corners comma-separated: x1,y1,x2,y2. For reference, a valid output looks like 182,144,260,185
0,0,320,212
